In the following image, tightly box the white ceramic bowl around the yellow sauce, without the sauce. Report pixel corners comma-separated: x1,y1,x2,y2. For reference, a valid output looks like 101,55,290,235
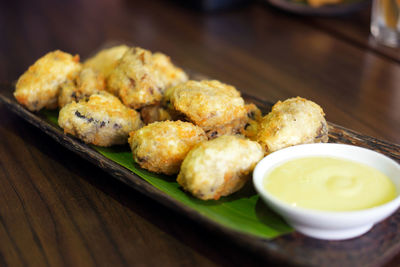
253,144,400,240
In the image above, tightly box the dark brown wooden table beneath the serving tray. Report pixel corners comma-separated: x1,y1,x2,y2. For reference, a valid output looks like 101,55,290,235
0,0,400,266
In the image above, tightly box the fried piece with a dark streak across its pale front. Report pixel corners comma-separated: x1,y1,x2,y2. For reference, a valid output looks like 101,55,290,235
58,92,142,146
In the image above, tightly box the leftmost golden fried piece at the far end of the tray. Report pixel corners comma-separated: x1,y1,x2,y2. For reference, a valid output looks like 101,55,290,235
14,50,81,111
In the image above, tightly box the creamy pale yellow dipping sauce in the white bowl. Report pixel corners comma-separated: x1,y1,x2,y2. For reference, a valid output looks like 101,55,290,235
264,157,397,211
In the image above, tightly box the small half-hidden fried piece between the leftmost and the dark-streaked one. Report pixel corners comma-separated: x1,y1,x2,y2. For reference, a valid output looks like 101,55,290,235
58,68,105,108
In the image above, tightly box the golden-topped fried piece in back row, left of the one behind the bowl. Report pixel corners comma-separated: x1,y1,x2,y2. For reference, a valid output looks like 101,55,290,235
163,80,248,138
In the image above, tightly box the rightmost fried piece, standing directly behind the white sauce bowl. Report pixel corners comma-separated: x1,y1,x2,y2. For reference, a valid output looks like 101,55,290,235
254,97,328,153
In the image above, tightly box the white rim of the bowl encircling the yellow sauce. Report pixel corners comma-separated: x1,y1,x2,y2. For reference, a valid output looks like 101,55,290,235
253,143,400,218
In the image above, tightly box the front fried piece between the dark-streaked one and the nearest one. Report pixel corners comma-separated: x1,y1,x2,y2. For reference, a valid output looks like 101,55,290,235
129,121,207,175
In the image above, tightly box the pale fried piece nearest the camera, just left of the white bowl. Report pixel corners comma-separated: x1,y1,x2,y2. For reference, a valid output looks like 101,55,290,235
177,135,264,200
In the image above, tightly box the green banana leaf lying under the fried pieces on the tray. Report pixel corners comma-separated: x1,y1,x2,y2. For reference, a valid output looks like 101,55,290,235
41,110,293,239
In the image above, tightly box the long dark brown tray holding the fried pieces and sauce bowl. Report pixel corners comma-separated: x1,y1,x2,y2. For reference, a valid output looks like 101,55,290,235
0,84,400,267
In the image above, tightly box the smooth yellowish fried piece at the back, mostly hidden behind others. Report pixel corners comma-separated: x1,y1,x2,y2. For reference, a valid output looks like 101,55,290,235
83,45,129,78
